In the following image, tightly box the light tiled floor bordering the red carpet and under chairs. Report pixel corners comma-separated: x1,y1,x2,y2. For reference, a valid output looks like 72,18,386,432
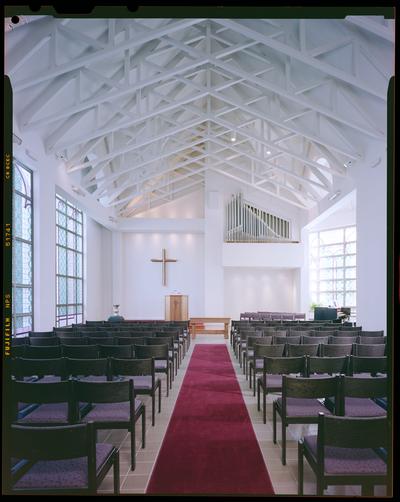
99,335,385,497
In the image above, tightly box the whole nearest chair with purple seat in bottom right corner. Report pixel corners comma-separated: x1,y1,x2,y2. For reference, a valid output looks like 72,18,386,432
298,413,389,496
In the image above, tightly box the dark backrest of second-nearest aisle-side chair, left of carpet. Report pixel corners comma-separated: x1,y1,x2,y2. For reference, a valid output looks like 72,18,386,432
73,380,135,404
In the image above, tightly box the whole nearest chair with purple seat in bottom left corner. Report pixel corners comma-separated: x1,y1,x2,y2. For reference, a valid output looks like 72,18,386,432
6,423,119,495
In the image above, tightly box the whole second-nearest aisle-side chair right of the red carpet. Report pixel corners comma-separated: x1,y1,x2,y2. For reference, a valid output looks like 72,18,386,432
272,375,339,465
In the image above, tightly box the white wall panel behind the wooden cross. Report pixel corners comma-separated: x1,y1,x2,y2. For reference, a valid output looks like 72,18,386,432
120,233,204,319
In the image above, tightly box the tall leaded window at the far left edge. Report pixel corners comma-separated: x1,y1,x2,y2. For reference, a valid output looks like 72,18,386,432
12,159,33,336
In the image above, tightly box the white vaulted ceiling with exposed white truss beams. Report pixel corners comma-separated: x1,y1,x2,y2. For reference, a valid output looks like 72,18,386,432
6,16,394,217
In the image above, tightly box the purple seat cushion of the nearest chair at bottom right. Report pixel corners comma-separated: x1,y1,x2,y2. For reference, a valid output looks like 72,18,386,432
304,436,387,476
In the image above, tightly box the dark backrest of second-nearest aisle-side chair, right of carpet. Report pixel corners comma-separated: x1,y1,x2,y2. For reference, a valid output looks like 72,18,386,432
282,375,339,408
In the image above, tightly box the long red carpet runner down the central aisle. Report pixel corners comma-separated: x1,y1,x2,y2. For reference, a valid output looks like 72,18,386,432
147,344,274,495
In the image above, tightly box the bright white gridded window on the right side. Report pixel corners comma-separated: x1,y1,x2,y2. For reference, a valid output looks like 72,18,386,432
309,226,357,320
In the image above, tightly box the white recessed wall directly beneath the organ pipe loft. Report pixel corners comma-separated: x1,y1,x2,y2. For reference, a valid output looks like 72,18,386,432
224,267,298,319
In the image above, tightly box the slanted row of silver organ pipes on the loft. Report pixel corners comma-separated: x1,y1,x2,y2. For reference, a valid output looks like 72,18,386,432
225,193,294,242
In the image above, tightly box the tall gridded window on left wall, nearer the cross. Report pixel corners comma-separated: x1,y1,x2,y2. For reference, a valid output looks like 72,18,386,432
56,194,83,326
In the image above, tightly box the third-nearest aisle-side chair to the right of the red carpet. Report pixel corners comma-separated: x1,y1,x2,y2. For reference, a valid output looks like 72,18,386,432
257,356,306,424
